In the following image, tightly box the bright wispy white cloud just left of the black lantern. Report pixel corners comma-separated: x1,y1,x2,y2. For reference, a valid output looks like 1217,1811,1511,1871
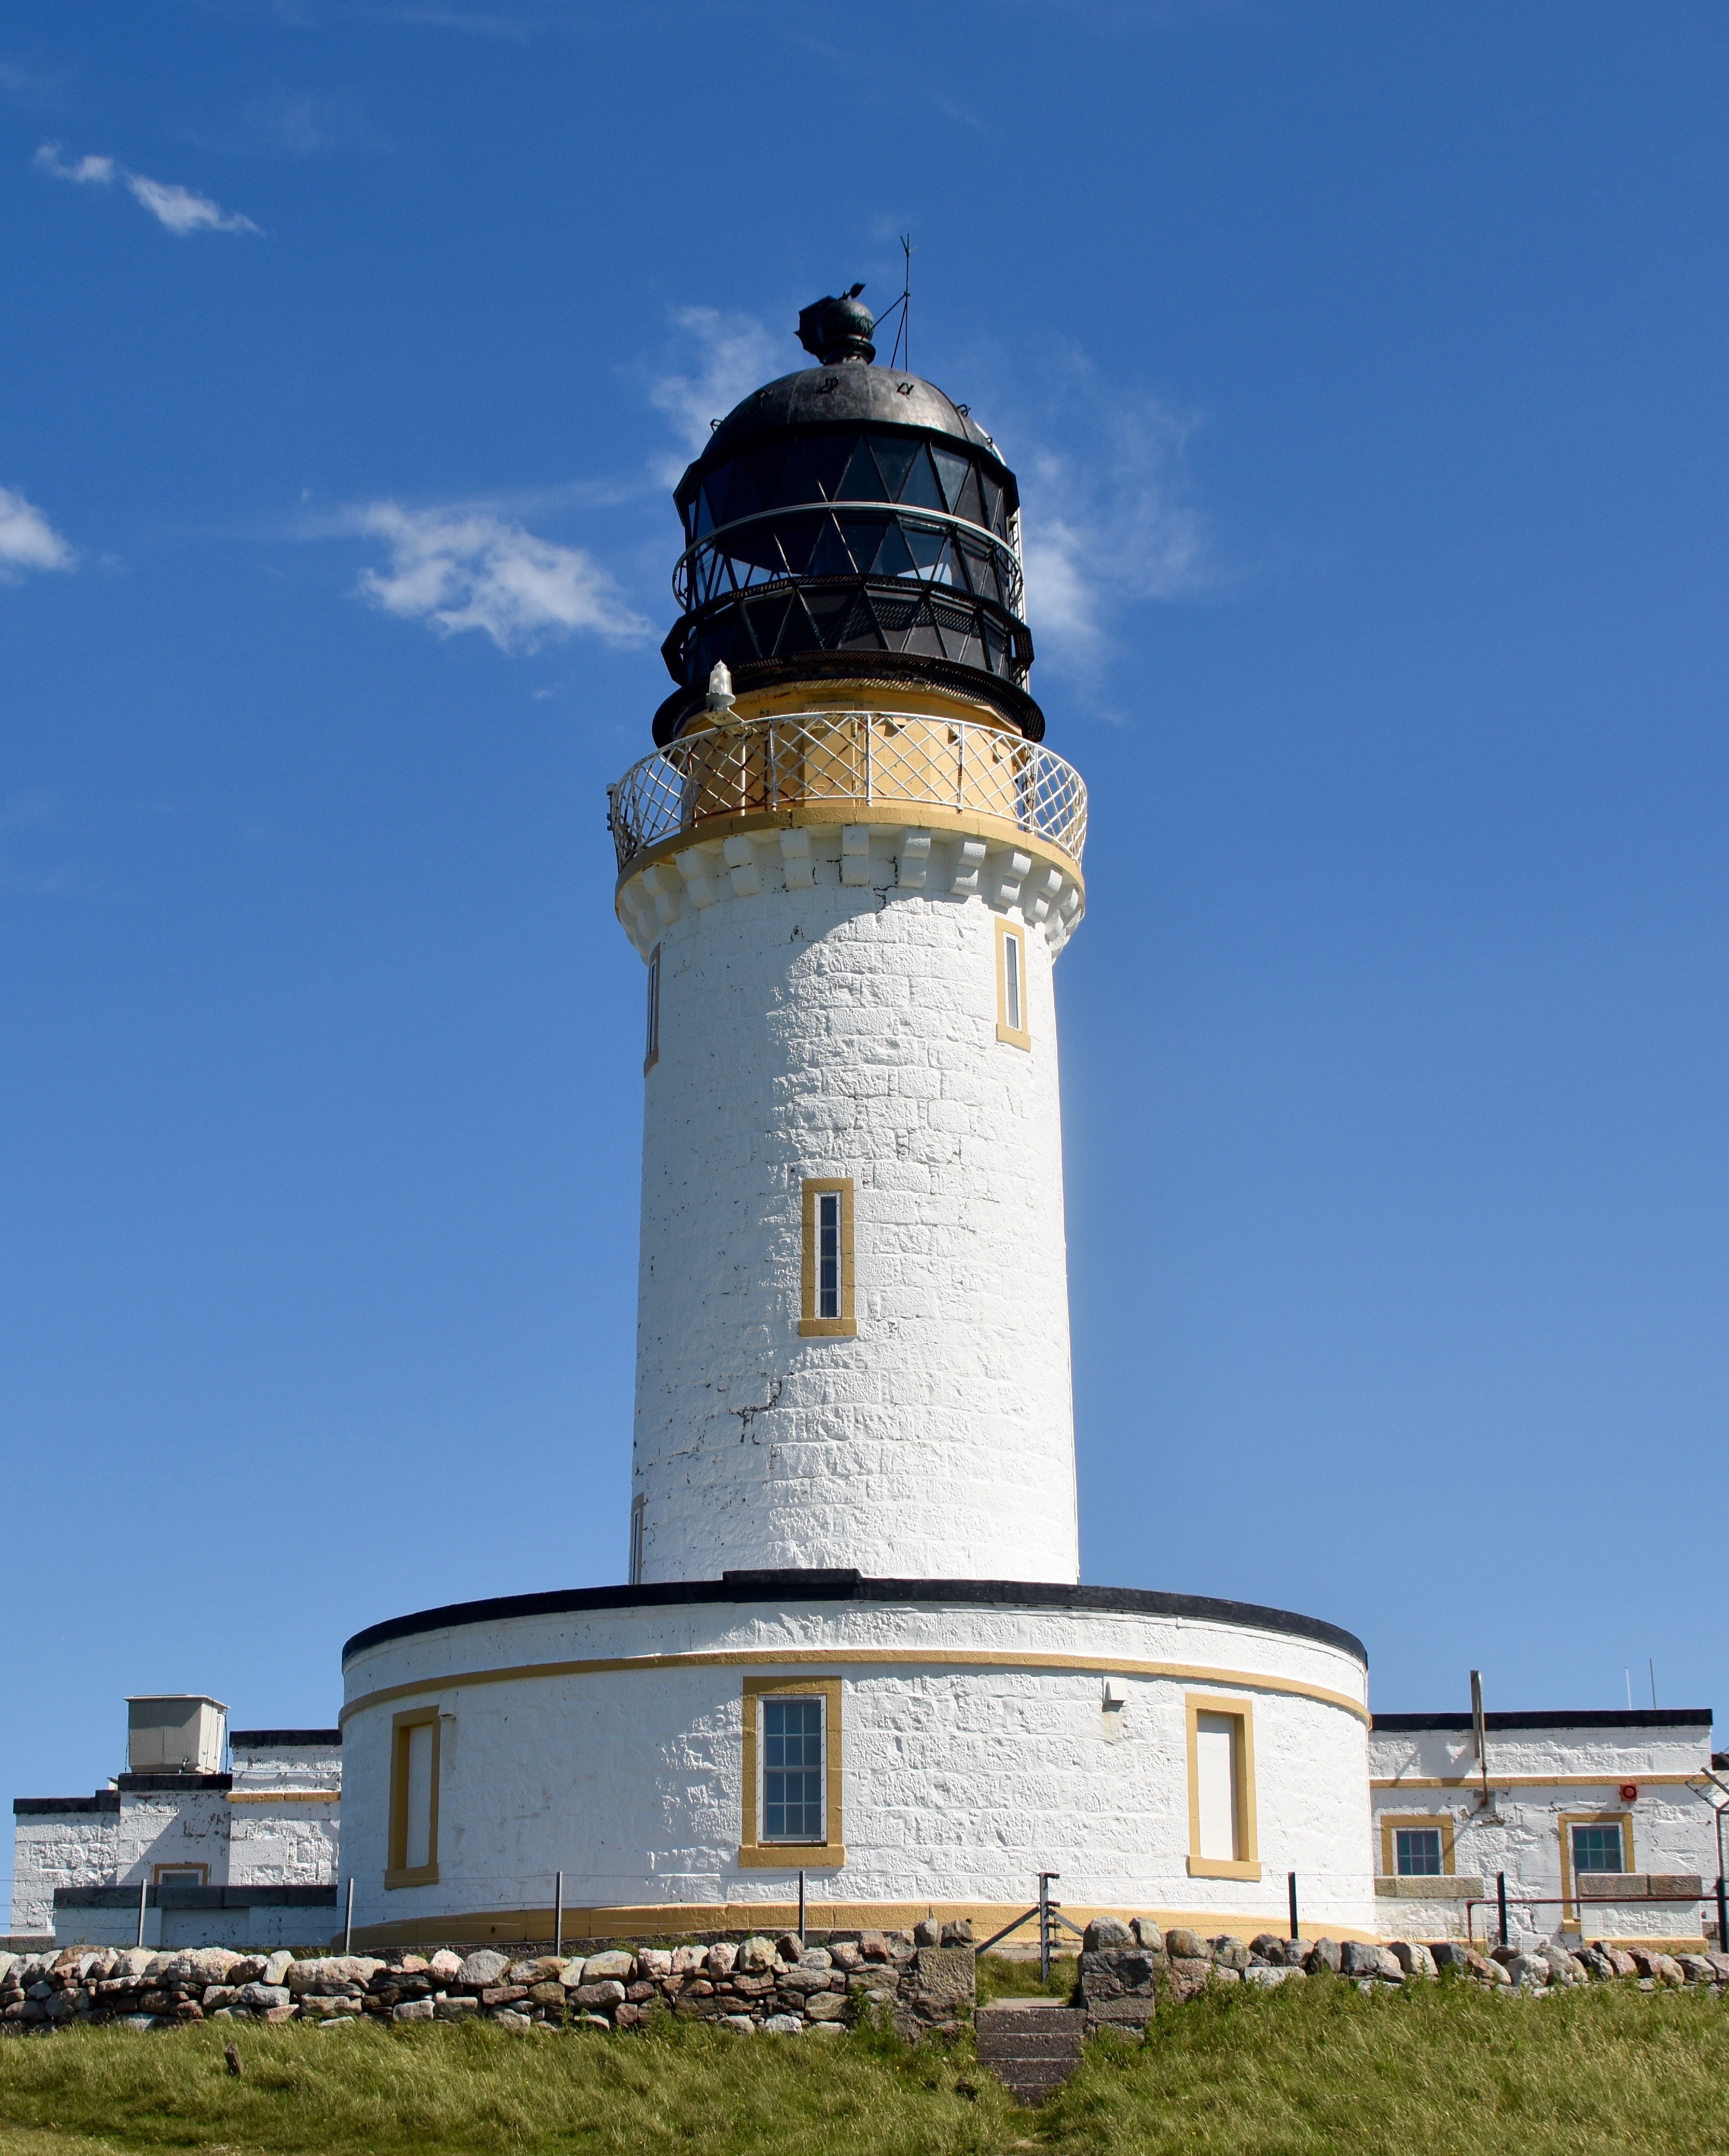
349,502,651,651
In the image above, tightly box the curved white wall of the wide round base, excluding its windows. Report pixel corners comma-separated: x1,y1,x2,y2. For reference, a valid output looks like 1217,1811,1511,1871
343,1591,1373,1938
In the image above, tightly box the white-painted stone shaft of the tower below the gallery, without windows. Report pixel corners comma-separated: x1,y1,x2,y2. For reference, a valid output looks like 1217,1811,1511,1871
621,824,1080,1580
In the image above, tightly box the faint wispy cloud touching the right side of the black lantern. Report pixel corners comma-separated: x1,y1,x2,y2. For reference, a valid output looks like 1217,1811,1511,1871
1020,360,1227,660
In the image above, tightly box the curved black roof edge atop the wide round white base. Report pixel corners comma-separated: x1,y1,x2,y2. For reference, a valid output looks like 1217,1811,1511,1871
343,1570,1369,1669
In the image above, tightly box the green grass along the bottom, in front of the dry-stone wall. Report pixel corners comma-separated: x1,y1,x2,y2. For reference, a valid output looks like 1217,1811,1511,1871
0,1971,1729,2156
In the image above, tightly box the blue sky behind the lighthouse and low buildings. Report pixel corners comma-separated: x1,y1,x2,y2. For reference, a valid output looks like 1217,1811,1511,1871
0,0,1729,1854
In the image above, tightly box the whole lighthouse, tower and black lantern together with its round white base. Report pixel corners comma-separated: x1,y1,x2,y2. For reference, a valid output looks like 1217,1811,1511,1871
343,300,1373,1943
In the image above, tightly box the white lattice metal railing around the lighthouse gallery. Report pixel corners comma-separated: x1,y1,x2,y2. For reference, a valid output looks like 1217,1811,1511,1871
606,711,1086,875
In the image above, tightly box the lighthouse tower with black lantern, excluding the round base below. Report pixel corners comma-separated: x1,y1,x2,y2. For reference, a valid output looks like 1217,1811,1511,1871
612,298,1086,1583
